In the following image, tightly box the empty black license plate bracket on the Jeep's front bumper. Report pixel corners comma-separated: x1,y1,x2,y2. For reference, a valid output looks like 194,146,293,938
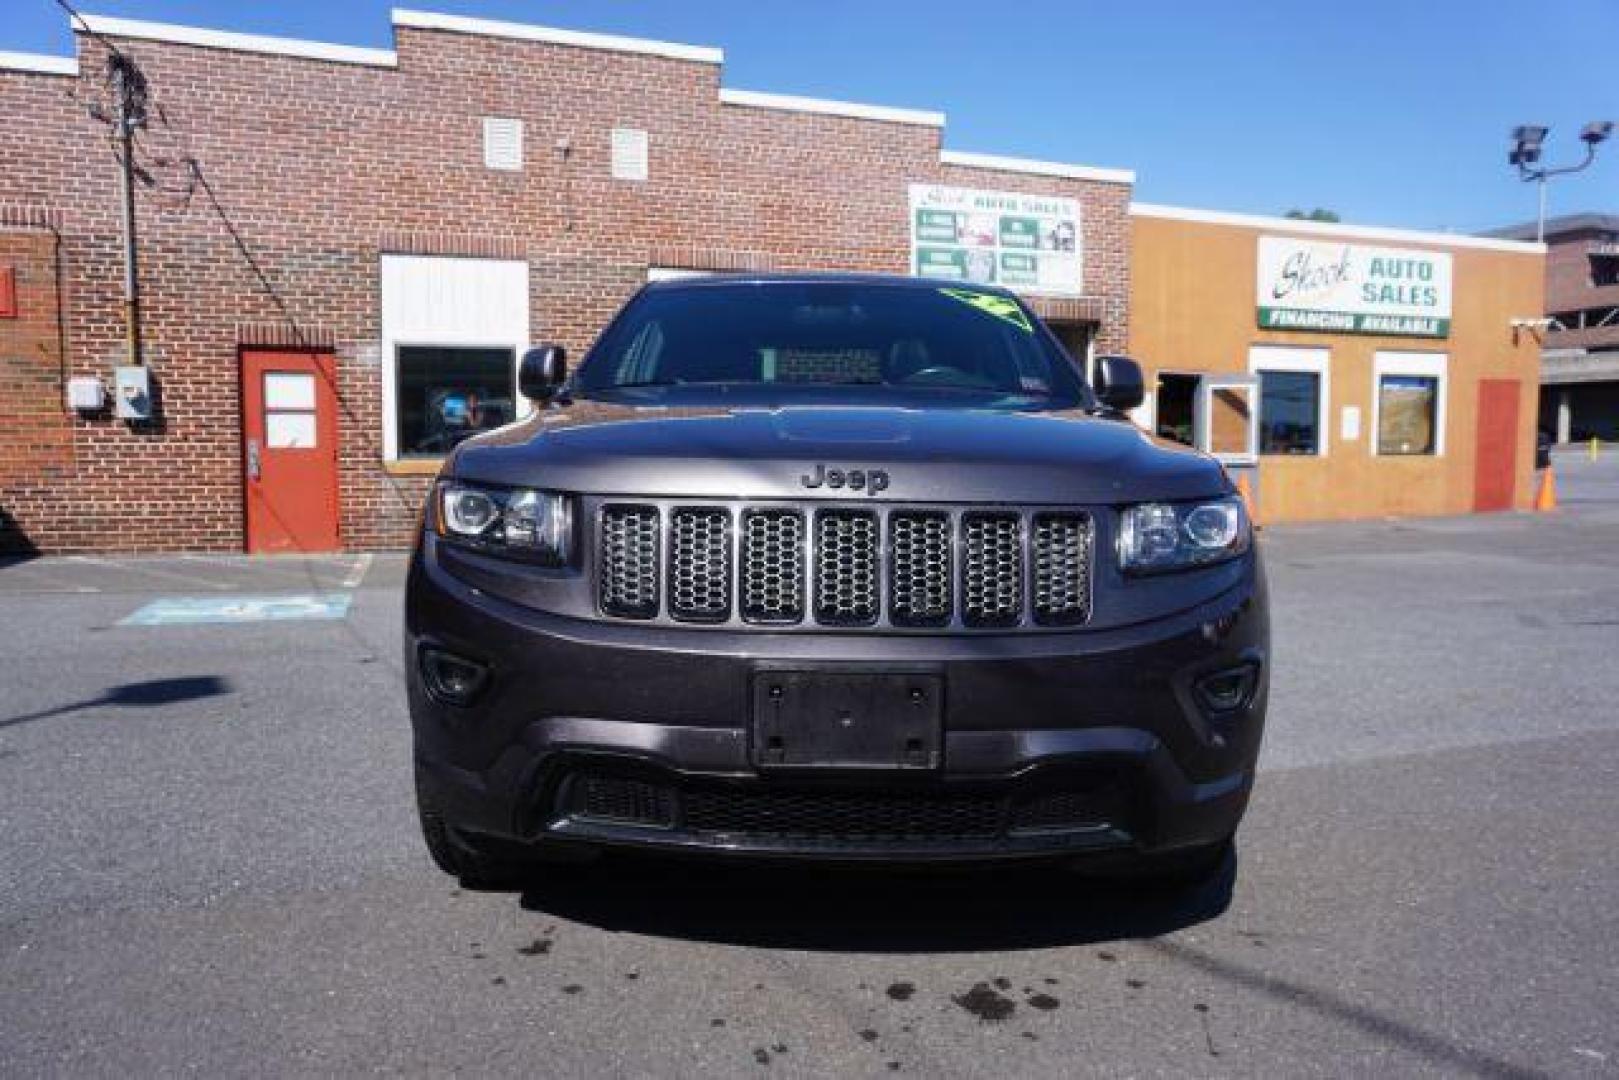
753,670,944,772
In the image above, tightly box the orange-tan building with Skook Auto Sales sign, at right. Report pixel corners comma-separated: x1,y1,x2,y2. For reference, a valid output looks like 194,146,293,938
1130,204,1545,521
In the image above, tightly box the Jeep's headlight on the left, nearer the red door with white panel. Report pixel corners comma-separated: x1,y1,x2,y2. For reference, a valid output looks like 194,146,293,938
434,481,573,567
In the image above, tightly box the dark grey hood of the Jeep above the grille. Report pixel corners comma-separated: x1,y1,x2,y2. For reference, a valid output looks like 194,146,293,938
445,402,1227,504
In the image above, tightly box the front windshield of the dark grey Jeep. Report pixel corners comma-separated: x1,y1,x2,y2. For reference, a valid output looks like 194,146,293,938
575,282,1090,408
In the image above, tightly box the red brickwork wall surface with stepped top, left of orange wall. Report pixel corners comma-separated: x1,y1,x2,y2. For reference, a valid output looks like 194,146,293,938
0,28,1130,551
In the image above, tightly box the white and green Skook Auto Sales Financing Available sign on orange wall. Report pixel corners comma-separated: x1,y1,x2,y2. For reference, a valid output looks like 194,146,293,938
1258,236,1451,337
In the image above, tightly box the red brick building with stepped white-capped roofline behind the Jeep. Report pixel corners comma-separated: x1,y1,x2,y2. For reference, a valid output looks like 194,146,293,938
0,11,1133,551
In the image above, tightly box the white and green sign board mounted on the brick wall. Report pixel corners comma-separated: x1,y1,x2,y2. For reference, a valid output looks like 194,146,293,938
910,183,1085,296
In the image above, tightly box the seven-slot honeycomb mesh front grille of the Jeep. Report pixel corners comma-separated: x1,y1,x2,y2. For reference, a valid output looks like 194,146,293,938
596,502,1094,630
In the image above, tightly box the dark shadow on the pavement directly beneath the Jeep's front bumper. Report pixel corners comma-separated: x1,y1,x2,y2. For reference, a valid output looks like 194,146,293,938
521,857,1237,952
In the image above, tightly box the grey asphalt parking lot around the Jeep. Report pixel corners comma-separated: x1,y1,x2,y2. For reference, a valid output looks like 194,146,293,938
0,450,1619,1077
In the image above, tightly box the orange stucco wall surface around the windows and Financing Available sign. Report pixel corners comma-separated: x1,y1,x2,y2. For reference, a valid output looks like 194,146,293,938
1130,214,1545,521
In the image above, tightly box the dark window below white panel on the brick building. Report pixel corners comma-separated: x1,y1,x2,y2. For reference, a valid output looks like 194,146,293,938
395,345,516,458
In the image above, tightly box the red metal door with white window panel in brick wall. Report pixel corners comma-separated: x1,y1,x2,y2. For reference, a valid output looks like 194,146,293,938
241,351,338,554
